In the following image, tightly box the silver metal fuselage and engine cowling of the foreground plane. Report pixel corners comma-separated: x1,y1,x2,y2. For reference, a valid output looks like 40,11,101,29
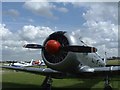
42,33,106,72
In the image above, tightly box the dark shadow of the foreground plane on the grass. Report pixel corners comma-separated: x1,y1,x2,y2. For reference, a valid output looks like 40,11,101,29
2,79,119,90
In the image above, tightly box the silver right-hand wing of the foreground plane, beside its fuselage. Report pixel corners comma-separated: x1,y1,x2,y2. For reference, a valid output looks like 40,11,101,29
79,66,120,76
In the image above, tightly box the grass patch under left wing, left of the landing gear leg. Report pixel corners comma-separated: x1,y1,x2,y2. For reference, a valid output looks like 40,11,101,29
2,70,44,88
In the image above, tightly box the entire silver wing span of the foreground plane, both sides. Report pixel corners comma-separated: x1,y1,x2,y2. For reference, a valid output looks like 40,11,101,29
2,66,120,78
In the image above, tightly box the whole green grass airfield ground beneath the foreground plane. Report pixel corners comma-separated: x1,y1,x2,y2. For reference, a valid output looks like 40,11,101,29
0,61,120,90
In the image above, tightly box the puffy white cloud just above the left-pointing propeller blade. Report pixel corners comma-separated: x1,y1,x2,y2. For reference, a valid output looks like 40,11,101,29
19,25,54,41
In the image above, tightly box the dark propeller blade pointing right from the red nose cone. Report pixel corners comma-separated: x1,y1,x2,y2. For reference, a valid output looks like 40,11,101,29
61,46,97,53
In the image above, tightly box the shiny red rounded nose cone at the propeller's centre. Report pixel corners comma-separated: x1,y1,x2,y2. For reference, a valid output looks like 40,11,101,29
45,40,61,54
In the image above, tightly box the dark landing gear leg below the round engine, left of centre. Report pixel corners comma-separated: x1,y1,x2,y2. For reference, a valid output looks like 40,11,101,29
41,76,52,90
